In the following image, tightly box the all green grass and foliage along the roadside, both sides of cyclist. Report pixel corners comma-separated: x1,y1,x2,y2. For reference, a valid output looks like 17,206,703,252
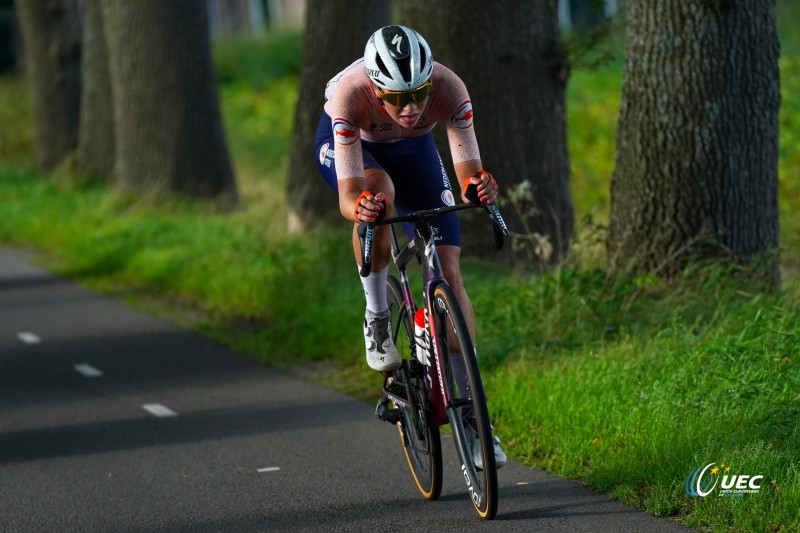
0,5,800,531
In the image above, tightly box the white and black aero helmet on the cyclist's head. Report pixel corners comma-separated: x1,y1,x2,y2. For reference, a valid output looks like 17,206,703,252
364,26,433,91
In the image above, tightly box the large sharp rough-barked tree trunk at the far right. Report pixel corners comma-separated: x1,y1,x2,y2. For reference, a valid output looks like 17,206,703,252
608,0,780,275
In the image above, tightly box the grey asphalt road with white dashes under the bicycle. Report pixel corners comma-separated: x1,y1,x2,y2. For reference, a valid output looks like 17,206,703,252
0,250,687,533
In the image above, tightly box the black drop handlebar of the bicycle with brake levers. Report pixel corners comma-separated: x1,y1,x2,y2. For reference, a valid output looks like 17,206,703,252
358,184,508,278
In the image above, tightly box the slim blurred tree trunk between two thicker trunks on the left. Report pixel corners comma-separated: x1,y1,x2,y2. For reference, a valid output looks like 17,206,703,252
77,0,115,178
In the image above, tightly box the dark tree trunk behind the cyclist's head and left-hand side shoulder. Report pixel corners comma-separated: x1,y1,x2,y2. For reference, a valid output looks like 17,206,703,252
287,0,390,230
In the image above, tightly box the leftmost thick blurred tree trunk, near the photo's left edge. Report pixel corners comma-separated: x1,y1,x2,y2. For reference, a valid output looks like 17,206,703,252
17,0,81,170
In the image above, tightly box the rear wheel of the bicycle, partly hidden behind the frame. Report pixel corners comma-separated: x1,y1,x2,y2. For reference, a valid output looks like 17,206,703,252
386,276,442,500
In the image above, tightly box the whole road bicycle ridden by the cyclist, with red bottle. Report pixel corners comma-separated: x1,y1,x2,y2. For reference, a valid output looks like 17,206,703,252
358,185,508,520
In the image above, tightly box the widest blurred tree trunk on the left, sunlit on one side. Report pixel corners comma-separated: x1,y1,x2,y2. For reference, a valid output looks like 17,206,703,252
102,0,237,205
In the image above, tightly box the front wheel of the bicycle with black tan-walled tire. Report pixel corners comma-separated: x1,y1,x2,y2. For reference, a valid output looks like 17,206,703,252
432,283,498,520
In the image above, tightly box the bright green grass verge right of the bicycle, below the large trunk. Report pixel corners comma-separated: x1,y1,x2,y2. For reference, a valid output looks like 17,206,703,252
486,266,800,531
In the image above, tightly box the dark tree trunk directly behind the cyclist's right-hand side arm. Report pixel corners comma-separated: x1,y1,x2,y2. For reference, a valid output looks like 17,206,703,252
399,0,574,269
